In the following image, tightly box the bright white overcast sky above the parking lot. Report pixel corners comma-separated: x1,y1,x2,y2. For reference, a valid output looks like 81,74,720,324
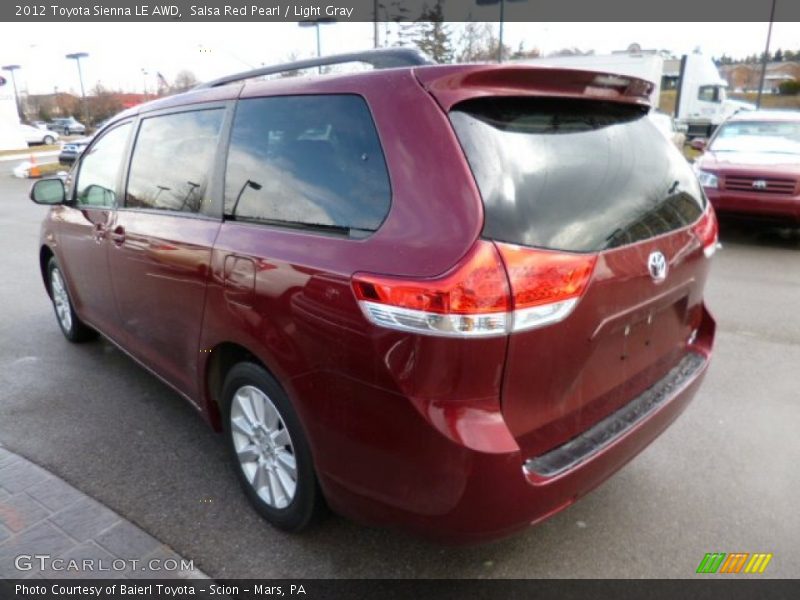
0,22,800,94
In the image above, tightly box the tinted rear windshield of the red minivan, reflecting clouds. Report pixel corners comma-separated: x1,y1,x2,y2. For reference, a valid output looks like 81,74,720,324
450,98,705,252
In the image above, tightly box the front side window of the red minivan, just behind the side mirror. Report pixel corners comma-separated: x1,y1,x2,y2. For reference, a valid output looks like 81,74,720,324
75,123,131,207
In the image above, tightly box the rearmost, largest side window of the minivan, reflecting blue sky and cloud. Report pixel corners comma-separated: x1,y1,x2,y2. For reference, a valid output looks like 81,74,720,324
225,95,391,233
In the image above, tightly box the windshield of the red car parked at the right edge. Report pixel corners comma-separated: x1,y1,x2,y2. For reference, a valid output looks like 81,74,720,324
710,120,800,155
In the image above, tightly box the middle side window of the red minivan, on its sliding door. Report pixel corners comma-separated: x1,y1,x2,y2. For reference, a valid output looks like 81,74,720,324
125,109,225,213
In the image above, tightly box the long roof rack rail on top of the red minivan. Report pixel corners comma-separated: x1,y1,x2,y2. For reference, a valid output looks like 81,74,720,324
194,48,435,90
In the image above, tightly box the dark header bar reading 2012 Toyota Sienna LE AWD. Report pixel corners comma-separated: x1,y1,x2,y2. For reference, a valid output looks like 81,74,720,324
0,0,800,22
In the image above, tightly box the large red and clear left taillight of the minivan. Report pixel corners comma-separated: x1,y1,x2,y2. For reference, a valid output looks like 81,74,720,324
353,240,596,337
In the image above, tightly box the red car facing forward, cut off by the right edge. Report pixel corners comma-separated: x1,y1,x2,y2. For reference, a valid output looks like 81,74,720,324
693,110,800,222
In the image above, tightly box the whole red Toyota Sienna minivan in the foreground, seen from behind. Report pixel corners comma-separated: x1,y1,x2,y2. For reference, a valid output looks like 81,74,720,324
31,49,717,540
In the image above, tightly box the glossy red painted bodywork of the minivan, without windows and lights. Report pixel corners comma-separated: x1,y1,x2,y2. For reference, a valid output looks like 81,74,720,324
37,66,716,540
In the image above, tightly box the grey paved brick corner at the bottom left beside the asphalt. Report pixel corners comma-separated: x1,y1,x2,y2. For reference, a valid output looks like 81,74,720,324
0,445,209,579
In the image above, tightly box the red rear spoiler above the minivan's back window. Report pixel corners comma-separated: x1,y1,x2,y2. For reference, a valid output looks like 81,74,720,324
414,65,654,111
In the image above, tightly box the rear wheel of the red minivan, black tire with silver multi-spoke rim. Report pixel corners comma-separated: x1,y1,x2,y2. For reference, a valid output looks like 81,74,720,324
222,362,325,532
